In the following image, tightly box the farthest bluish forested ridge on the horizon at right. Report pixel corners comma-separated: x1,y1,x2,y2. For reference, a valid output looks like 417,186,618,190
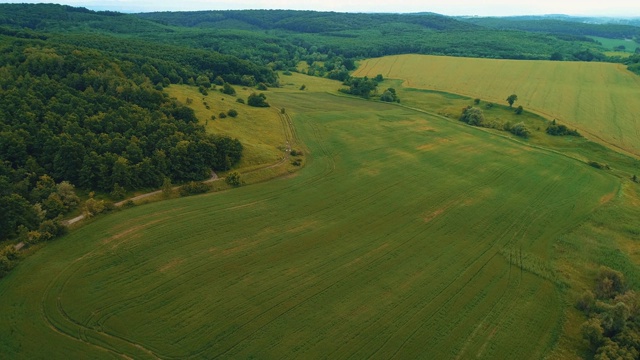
461,16,640,40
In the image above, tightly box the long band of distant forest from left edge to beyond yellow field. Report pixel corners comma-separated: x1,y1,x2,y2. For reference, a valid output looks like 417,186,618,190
0,4,612,64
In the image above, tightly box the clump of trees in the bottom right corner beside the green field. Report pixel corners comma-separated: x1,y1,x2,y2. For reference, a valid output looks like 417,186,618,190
577,267,640,359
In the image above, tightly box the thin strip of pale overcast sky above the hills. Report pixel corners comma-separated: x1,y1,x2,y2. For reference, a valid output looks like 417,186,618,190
5,0,640,17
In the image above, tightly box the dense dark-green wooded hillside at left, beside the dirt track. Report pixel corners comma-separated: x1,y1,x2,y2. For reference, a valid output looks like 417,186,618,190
0,32,252,246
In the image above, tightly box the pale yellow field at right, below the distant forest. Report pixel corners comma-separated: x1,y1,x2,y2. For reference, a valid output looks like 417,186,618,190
354,55,640,156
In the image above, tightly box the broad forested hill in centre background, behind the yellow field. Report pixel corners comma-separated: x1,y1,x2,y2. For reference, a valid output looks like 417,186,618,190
132,10,596,63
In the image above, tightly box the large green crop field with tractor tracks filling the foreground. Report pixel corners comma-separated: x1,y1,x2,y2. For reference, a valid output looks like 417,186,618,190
0,74,620,359
